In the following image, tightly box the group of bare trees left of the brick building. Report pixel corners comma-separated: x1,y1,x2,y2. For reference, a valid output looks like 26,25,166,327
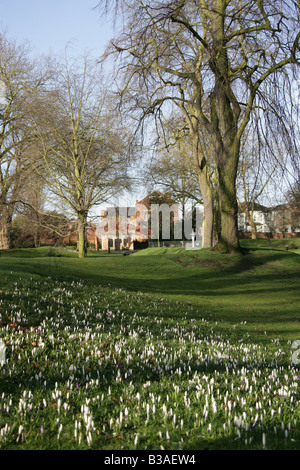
0,36,132,257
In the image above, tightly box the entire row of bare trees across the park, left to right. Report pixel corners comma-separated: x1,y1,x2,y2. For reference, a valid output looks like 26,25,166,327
0,0,300,257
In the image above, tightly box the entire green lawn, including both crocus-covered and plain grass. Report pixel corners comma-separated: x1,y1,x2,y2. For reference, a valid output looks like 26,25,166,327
0,239,300,450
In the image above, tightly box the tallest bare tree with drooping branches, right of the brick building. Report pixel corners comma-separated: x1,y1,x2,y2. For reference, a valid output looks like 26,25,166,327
99,0,300,252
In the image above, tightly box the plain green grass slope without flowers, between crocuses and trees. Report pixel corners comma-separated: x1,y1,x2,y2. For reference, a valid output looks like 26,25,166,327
0,239,300,341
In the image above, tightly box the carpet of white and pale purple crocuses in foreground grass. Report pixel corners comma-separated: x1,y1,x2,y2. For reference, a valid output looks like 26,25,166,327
0,278,300,450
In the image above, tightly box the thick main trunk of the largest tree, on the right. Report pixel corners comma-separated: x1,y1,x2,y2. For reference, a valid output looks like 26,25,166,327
209,4,240,253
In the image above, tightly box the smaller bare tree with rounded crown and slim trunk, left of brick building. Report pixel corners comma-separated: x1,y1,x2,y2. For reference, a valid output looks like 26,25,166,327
31,57,130,258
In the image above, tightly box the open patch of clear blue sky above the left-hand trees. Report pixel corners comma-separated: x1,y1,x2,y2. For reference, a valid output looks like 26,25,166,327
0,0,113,57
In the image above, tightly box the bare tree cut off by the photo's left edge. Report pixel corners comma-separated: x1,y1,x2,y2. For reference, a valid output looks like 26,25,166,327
0,35,46,249
